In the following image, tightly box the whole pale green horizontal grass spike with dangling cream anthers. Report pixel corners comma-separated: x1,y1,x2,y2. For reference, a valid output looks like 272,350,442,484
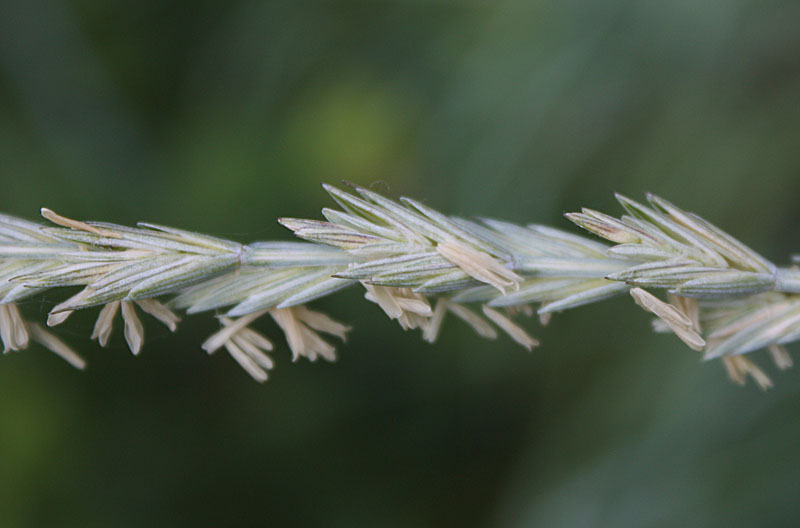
0,185,800,388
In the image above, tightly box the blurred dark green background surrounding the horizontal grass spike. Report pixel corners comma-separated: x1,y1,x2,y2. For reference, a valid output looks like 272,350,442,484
0,0,800,528
